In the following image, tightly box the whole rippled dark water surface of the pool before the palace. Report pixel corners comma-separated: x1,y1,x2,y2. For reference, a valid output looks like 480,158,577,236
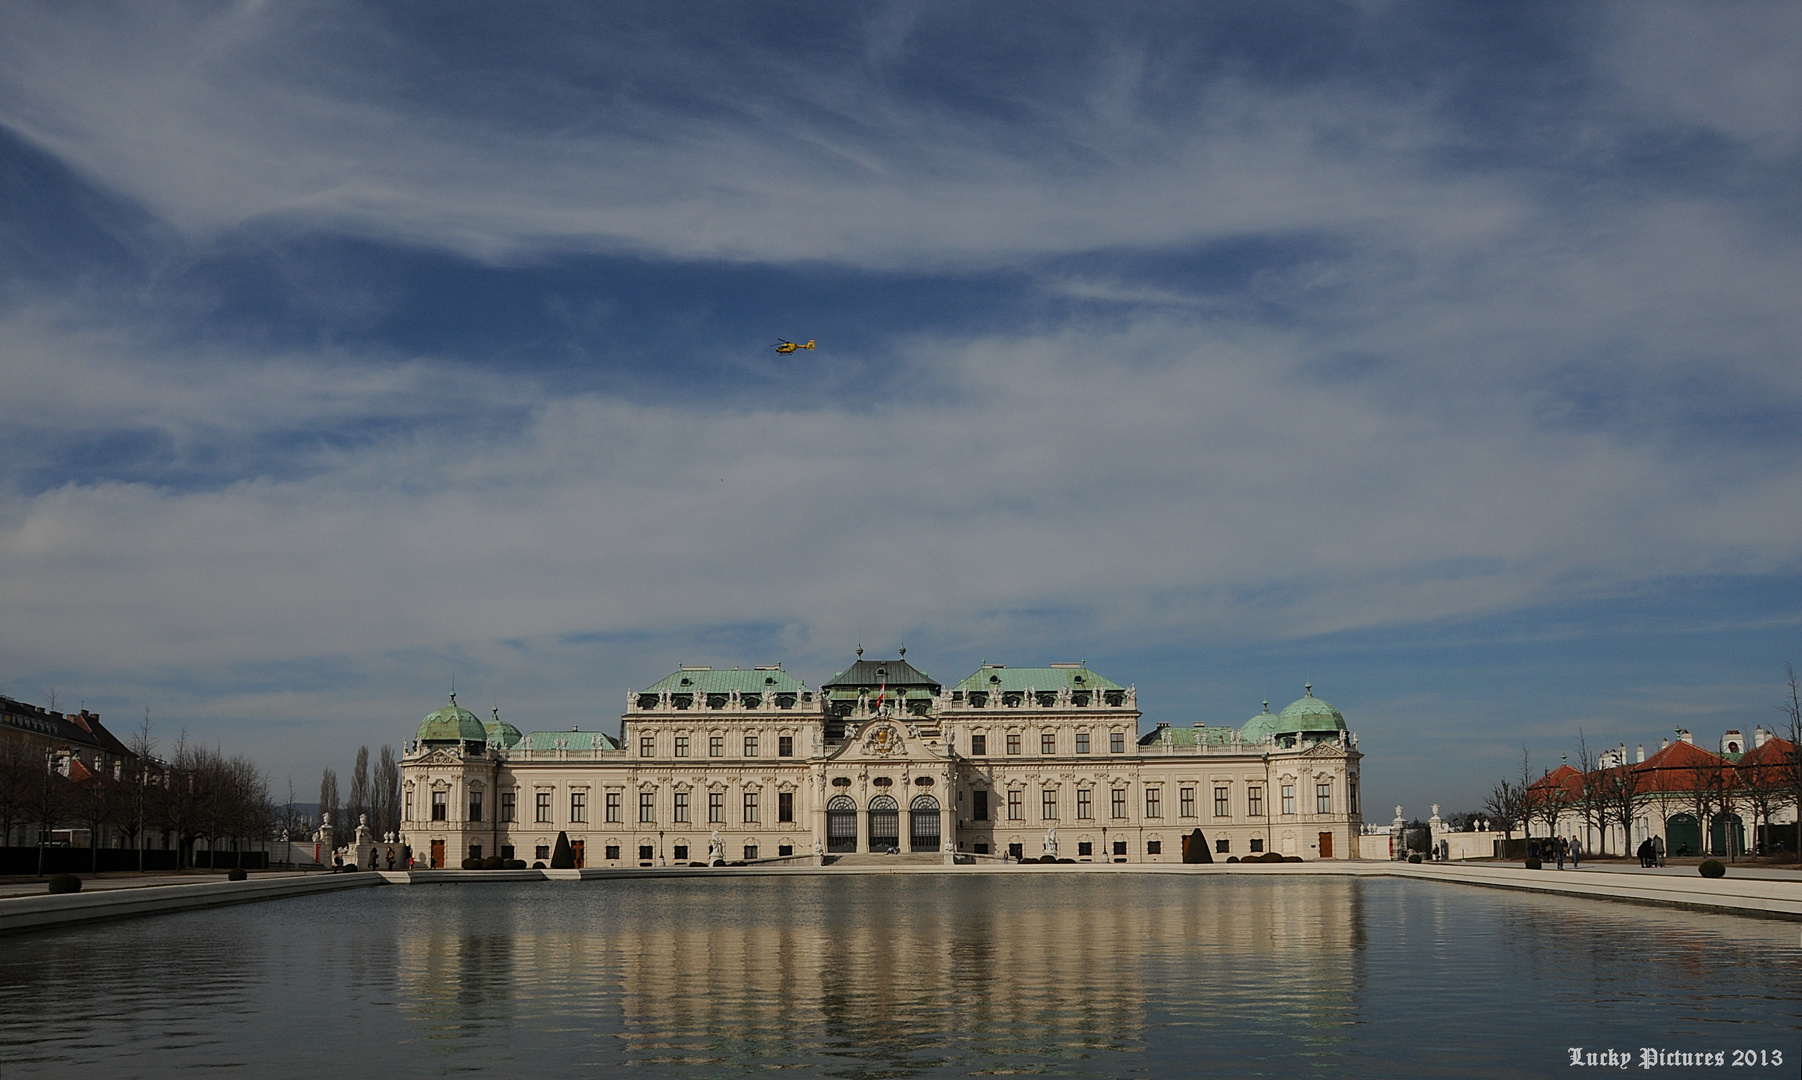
0,873,1802,1080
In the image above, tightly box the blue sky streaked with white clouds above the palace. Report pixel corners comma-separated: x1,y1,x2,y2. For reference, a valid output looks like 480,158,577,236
0,4,1802,817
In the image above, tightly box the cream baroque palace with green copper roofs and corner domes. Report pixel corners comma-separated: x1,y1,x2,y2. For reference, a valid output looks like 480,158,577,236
398,649,1362,867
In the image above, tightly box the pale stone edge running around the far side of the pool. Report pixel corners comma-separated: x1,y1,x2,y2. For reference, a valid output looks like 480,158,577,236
0,862,1802,936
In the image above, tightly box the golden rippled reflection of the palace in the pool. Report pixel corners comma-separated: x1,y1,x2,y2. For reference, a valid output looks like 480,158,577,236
387,871,1364,1066
